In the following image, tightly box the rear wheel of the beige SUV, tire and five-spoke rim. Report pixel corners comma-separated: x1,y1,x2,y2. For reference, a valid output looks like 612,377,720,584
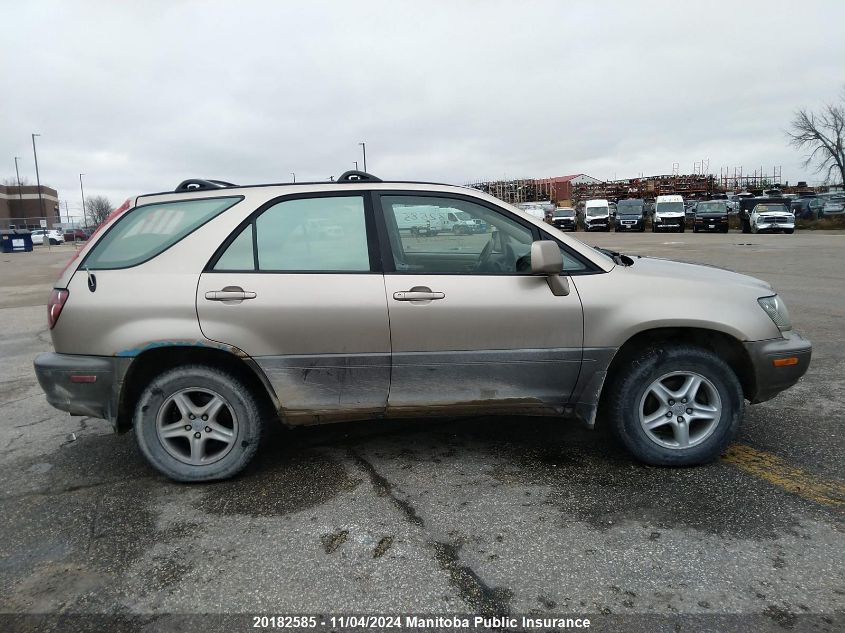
134,365,262,481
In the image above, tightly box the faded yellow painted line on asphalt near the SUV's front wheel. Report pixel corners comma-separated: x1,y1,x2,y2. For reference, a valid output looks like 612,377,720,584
722,444,845,507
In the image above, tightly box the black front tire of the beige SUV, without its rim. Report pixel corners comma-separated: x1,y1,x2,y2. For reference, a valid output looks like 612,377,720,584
604,344,744,466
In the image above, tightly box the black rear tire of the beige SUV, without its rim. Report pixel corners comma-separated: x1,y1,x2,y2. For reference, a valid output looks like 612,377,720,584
133,365,263,482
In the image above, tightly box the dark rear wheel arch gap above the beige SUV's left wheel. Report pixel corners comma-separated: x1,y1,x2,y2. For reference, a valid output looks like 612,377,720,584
115,346,279,433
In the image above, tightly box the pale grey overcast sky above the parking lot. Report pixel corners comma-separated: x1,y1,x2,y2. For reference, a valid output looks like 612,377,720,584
0,0,845,214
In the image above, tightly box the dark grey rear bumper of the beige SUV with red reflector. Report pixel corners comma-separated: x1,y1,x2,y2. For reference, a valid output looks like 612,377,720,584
34,352,132,424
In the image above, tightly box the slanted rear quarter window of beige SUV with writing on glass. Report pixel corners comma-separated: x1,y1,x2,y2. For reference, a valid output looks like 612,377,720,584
82,196,243,270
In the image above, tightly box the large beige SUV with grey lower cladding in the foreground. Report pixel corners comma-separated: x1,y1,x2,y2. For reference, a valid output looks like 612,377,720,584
35,172,811,481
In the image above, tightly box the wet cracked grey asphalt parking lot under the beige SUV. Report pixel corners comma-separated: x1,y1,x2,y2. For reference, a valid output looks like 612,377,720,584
0,231,845,631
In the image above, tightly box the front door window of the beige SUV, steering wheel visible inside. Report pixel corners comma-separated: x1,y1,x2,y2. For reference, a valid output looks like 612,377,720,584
381,196,534,274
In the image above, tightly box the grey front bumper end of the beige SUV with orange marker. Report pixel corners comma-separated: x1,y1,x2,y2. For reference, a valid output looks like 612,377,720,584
744,330,813,403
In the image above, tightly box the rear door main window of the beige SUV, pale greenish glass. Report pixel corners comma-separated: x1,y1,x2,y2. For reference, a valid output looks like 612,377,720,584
254,196,370,272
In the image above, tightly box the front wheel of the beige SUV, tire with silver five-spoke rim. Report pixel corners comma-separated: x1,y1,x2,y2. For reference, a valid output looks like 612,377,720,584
609,345,744,466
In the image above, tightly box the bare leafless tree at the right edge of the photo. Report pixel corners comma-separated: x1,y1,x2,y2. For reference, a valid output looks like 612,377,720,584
787,91,845,184
